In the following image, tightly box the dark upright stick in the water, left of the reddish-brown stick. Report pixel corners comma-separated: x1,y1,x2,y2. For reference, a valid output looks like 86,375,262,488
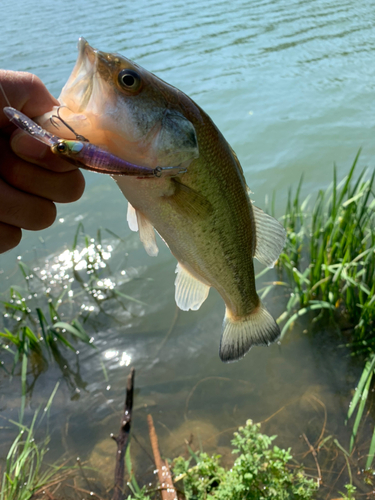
111,368,135,500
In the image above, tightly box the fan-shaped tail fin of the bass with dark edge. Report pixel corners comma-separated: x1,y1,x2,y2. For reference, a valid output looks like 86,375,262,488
219,302,280,363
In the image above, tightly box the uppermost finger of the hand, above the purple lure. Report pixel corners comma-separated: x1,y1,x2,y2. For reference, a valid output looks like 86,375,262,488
0,70,59,129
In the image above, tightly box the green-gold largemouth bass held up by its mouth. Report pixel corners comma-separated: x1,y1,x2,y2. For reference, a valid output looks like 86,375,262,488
37,38,285,362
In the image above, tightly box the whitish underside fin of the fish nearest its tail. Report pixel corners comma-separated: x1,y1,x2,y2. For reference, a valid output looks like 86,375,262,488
175,263,210,311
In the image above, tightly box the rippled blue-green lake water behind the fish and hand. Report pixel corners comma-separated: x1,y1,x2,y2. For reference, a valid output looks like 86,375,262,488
0,0,375,496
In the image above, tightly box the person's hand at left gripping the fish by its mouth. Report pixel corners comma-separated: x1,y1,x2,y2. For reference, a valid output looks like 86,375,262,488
0,70,85,253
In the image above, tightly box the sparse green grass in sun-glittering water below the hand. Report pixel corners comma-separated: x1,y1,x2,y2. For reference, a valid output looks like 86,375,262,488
0,223,144,395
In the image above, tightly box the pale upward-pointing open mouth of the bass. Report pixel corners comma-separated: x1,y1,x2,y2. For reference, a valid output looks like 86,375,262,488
59,37,98,113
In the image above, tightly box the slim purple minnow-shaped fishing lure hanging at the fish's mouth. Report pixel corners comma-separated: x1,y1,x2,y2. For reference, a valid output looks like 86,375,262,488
3,106,187,179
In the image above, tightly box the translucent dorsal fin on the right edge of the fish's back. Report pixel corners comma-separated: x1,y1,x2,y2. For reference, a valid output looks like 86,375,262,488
252,205,286,267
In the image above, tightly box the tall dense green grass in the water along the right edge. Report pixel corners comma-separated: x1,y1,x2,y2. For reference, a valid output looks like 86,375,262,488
278,152,375,468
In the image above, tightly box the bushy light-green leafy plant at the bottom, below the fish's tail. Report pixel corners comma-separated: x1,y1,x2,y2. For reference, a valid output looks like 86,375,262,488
173,420,318,500
